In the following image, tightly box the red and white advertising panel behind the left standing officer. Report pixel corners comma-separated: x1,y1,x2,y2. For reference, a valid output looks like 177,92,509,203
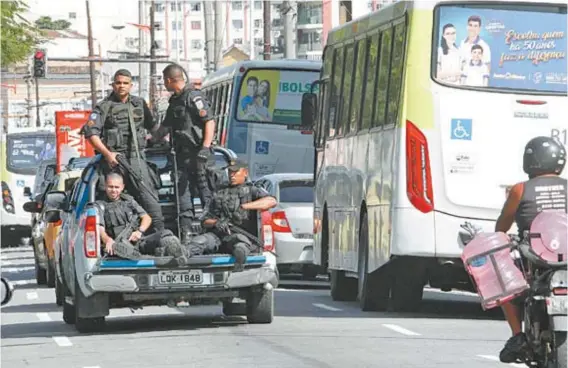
55,111,95,172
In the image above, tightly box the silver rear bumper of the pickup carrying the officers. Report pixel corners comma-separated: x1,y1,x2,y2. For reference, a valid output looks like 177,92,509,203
85,266,278,294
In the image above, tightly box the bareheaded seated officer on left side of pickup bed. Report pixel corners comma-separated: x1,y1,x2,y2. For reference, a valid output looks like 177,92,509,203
95,173,181,259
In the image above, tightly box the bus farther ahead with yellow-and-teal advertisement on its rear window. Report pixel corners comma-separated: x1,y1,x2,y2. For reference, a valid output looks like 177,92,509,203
201,60,321,180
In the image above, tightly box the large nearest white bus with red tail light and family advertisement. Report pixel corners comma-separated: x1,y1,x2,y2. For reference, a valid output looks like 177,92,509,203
303,0,568,310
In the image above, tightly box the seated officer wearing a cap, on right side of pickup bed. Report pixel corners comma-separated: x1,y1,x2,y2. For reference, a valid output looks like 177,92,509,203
182,160,277,270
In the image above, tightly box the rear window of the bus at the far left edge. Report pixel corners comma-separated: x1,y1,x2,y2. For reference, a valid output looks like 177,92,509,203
6,135,55,175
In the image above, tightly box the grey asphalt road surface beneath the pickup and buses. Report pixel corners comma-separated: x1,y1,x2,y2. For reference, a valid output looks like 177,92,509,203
0,247,521,368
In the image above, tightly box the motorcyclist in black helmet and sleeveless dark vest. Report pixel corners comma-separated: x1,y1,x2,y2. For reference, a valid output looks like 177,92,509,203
495,137,568,363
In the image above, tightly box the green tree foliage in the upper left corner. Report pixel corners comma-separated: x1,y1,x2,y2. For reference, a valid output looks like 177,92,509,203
0,0,41,67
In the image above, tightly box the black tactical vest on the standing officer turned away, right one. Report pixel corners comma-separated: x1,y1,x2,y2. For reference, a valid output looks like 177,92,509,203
166,88,203,154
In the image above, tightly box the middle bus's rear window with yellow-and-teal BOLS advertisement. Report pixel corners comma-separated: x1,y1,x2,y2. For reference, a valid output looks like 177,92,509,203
236,69,319,125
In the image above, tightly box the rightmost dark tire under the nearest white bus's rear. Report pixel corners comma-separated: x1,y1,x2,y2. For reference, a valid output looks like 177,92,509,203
391,258,426,312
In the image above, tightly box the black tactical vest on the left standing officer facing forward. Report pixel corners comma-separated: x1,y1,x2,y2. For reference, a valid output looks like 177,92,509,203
101,96,146,152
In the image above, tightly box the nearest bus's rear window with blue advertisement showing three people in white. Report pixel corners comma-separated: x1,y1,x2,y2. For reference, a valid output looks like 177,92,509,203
432,3,568,94
